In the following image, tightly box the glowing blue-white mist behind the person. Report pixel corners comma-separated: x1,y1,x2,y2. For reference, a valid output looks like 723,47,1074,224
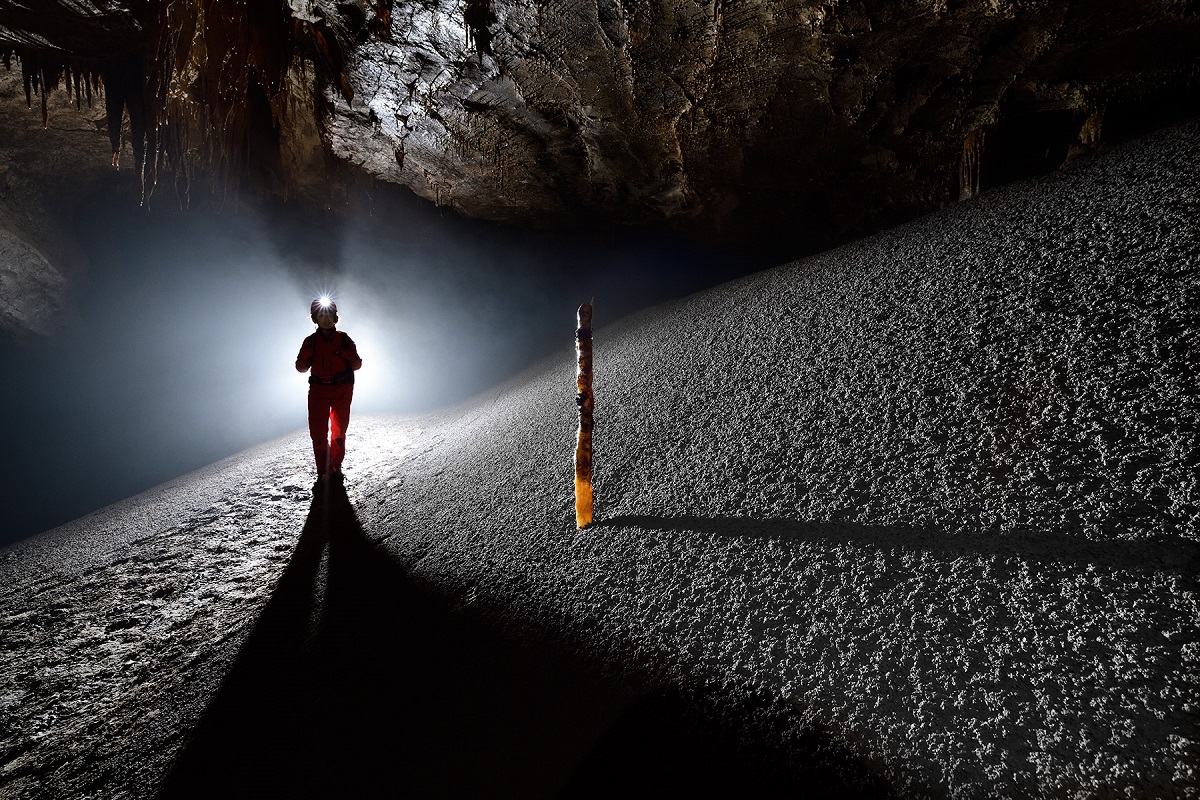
0,183,770,545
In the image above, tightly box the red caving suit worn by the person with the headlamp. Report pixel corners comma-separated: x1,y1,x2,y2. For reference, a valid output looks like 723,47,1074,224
296,329,362,476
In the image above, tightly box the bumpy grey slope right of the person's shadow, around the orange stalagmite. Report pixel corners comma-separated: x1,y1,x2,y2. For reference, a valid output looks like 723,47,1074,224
365,124,1200,798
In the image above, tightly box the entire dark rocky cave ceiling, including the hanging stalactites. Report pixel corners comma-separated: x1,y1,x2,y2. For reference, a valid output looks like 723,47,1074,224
0,0,1200,256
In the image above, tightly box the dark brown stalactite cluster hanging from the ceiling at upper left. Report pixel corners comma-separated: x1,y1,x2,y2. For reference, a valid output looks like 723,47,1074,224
0,0,376,206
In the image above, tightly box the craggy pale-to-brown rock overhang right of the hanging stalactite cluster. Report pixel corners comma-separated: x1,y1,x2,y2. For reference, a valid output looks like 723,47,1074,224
326,0,1200,246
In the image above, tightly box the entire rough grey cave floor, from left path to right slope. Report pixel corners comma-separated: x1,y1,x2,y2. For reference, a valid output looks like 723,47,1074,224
0,122,1200,798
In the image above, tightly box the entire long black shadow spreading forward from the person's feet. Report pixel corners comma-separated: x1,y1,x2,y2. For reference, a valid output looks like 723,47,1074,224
158,485,887,800
